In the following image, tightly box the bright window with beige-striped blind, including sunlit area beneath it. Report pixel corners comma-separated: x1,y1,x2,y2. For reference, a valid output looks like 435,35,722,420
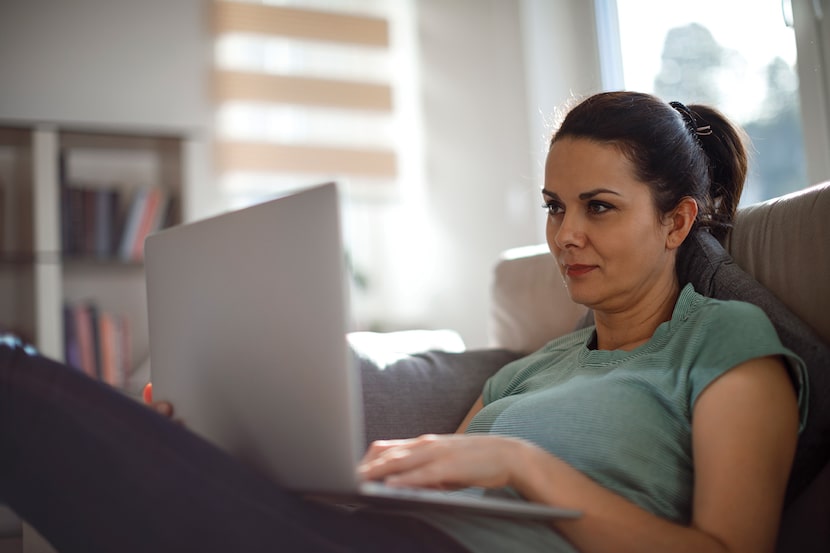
213,0,423,329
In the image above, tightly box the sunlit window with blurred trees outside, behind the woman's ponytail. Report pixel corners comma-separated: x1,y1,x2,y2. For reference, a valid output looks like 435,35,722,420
617,0,808,204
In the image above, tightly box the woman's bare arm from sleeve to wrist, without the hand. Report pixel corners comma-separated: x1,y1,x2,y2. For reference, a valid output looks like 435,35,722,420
523,358,798,553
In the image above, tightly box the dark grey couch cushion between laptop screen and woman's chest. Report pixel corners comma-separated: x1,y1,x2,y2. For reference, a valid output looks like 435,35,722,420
354,349,520,445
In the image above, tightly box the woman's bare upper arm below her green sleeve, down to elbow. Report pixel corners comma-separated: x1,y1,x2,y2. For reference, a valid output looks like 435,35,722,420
692,358,798,551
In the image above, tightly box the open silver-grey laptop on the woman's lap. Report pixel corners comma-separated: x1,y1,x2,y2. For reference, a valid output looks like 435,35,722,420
144,183,578,519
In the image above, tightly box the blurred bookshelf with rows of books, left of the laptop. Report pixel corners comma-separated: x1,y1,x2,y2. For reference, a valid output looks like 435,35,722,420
0,121,192,393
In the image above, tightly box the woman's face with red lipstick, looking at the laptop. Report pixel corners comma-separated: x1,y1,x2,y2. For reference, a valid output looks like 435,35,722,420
542,138,674,312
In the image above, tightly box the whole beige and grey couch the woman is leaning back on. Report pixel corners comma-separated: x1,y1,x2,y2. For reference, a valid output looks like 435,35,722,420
353,182,830,553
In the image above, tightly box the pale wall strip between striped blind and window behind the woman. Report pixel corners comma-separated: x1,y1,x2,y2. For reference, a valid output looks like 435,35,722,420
417,0,600,347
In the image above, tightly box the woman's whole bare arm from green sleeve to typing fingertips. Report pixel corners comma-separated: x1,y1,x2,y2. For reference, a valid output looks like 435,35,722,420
361,358,798,553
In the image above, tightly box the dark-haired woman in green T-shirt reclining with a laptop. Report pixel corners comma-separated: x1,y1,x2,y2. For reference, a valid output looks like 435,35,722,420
0,92,803,553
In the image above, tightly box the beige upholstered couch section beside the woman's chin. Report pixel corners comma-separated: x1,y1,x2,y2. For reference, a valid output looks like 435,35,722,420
489,245,587,353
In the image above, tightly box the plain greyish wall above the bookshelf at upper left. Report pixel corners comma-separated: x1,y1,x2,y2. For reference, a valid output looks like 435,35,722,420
0,0,211,131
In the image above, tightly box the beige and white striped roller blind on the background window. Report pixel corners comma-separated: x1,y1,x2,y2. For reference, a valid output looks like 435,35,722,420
213,0,400,203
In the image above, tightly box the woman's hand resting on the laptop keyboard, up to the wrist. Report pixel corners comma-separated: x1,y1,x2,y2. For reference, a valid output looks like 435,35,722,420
358,434,535,489
